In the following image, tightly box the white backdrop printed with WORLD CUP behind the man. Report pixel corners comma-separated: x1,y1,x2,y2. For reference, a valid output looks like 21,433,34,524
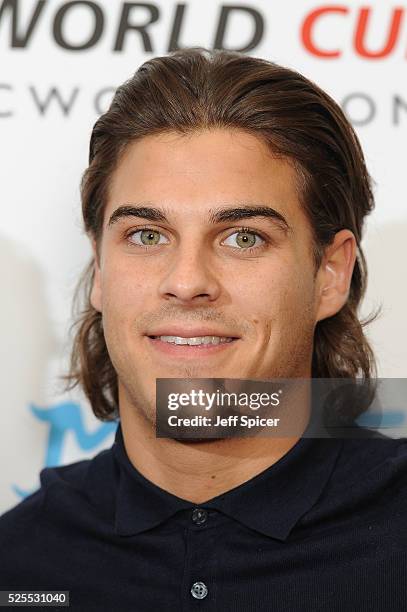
0,0,407,513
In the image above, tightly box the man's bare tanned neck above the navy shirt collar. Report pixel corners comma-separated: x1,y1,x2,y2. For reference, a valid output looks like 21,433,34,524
119,393,308,504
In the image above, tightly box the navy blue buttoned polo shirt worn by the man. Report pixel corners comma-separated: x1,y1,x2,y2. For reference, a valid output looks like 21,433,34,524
0,425,407,612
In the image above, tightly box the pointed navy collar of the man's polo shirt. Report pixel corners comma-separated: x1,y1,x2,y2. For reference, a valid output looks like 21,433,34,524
112,423,342,540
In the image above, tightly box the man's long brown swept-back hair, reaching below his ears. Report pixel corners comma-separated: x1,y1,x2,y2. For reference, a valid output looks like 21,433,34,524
63,47,375,420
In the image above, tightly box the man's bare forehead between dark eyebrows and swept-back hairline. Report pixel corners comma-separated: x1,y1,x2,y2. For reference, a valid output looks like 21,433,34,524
105,129,307,224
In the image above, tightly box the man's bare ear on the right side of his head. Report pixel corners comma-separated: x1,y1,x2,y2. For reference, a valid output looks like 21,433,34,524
316,229,357,321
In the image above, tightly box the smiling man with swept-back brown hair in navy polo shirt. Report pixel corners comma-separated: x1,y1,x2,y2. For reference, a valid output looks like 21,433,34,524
0,49,407,612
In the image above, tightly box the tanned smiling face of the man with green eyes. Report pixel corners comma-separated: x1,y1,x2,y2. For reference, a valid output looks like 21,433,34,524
92,130,350,424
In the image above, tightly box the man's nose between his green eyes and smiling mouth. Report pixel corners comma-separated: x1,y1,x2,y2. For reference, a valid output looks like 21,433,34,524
159,242,221,303
